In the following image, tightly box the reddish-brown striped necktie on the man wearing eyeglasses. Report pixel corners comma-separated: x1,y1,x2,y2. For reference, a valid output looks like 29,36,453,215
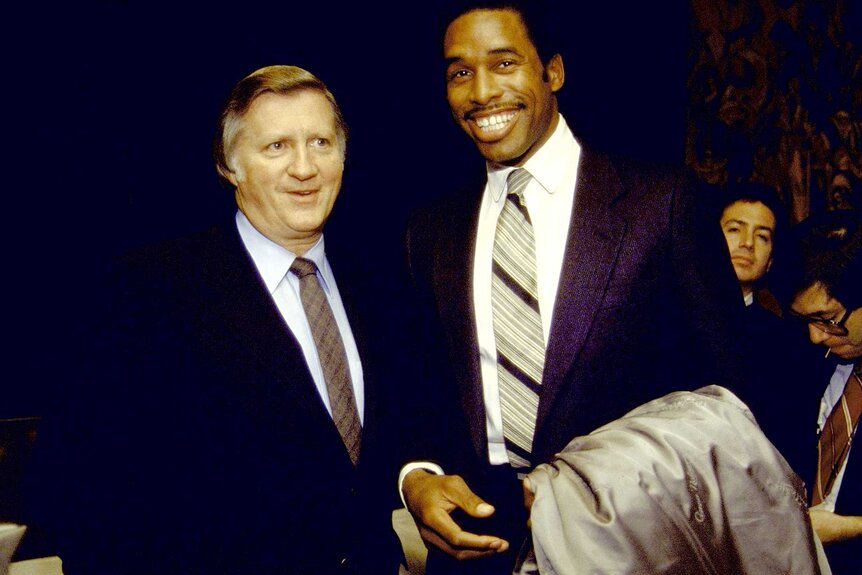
811,369,862,505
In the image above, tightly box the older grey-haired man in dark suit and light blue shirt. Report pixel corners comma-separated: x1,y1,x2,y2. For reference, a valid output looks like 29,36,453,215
27,66,400,575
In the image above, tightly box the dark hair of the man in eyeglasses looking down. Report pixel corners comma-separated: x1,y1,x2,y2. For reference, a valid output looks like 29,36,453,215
770,210,862,310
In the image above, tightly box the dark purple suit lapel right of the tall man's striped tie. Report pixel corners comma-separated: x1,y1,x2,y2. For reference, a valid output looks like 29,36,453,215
536,147,626,435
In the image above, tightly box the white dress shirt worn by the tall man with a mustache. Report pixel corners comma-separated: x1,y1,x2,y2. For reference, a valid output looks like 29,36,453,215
473,115,581,465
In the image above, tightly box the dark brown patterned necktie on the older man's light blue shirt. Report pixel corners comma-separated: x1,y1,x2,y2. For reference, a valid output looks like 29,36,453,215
290,258,362,465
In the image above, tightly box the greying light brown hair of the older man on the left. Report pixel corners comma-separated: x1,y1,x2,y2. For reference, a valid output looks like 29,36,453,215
213,65,347,189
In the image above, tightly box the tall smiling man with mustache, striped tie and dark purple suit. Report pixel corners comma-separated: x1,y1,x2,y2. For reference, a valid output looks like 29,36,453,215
400,2,746,573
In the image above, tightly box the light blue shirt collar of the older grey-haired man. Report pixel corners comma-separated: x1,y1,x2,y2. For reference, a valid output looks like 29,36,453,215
236,210,326,294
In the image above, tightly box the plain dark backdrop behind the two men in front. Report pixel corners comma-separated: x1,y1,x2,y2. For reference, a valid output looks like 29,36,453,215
0,2,689,417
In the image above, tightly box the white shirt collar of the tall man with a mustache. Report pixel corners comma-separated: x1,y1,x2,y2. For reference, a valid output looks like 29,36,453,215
486,114,581,202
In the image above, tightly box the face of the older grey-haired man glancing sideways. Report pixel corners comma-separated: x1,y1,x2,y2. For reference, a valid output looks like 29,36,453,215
228,89,344,255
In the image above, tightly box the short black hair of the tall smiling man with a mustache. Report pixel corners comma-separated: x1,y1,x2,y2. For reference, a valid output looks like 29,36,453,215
439,0,563,65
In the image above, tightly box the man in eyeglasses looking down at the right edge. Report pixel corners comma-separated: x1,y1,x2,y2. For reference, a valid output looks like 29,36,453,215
779,211,862,574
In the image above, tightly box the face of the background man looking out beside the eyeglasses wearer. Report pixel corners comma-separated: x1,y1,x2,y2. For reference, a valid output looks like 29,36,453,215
721,201,775,295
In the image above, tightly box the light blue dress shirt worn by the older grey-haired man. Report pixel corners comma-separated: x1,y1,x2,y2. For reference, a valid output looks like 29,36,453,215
236,211,365,421
